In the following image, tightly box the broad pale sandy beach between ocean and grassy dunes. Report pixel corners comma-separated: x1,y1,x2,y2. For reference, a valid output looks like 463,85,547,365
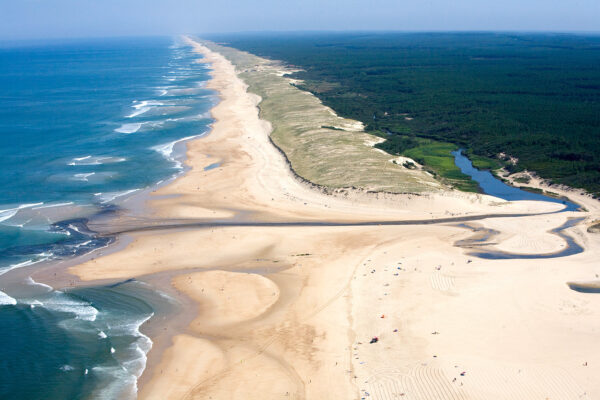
55,38,600,400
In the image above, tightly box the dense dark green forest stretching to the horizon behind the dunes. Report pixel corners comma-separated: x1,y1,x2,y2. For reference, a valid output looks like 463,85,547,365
210,32,600,196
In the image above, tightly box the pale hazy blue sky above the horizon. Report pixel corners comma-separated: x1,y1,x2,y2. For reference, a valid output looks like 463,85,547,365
0,0,600,40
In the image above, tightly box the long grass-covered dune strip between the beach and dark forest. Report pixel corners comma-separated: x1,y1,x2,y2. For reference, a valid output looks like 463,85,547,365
203,41,446,193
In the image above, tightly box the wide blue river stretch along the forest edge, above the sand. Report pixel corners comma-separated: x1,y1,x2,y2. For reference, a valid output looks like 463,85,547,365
452,149,581,212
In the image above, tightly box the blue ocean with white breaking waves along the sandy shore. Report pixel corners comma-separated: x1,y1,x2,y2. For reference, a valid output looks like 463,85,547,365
0,38,218,400
